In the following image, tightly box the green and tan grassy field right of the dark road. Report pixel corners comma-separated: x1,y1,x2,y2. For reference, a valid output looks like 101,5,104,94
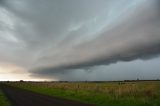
4,81,160,106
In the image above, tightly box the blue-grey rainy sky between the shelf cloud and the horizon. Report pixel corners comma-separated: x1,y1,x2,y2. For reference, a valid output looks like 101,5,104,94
32,58,160,81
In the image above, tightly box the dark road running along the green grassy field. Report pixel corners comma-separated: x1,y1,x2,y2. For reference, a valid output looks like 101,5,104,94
2,85,93,106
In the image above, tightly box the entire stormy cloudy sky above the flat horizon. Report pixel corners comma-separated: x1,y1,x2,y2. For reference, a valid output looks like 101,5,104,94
0,0,160,81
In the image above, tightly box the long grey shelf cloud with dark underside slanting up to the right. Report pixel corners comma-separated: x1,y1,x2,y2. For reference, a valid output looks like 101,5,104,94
32,0,160,78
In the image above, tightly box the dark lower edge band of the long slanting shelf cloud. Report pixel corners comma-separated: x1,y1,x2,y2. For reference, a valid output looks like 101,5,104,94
32,41,160,76
